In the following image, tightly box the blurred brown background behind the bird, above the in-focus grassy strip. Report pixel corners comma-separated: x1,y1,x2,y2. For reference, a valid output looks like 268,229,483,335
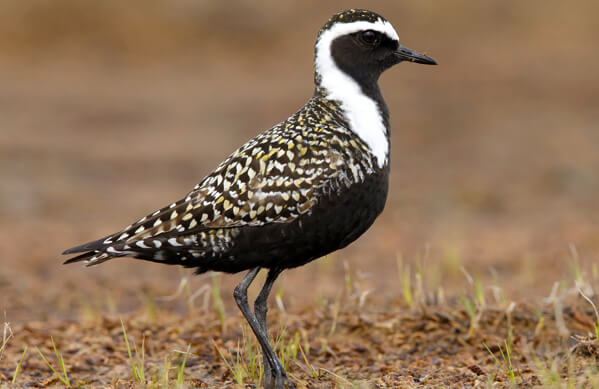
0,0,599,322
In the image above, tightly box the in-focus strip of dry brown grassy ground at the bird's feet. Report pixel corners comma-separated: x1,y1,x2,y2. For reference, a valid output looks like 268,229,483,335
0,262,599,388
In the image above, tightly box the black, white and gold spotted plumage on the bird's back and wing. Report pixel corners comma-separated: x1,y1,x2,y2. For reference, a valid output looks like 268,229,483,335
76,94,375,265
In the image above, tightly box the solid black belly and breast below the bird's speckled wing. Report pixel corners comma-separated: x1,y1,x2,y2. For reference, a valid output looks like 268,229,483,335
197,168,389,273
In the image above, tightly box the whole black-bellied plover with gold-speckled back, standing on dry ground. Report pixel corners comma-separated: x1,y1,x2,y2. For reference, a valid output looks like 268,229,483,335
63,9,437,389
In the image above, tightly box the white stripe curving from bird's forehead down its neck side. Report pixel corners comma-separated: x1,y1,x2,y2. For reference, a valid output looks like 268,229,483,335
314,20,399,168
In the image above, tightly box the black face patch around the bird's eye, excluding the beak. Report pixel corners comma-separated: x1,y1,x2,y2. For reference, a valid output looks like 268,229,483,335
331,30,401,86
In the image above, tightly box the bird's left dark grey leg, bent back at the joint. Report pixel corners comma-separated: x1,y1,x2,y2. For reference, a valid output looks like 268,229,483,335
233,267,285,389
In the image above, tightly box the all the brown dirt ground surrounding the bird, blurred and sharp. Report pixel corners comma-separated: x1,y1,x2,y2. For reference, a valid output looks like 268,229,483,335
0,0,599,388
